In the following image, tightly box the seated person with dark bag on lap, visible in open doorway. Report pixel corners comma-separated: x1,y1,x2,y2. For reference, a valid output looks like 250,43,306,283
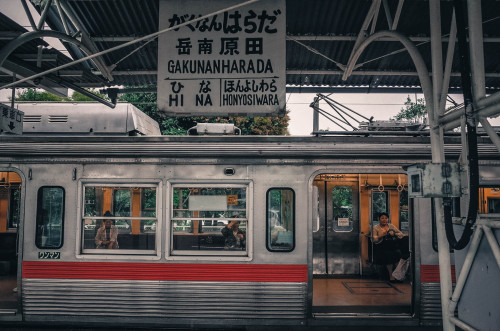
373,213,409,281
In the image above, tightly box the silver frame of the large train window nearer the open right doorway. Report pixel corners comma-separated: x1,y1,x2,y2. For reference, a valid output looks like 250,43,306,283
165,180,253,261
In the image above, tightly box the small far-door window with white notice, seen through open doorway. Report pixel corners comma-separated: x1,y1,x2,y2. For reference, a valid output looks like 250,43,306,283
332,186,353,232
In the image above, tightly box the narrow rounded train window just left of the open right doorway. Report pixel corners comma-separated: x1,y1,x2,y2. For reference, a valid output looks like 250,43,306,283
266,188,295,252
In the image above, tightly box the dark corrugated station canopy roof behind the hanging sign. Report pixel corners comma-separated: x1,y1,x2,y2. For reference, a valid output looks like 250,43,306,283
0,0,500,97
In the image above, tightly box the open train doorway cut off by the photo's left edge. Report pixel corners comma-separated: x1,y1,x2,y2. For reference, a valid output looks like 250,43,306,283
0,171,21,310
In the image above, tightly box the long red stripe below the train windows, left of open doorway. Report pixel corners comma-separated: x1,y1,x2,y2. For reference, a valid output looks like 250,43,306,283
22,261,307,282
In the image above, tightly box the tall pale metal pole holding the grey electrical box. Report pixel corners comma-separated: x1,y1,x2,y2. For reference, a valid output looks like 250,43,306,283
427,0,455,331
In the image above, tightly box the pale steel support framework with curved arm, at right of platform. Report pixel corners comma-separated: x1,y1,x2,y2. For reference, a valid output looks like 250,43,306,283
344,0,500,331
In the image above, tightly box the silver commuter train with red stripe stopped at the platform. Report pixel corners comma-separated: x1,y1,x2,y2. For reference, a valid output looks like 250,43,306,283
0,103,500,328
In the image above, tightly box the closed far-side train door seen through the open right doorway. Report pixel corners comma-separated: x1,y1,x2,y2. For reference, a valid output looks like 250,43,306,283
313,175,360,275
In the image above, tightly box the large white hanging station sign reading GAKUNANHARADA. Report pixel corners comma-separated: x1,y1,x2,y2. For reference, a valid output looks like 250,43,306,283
157,0,286,116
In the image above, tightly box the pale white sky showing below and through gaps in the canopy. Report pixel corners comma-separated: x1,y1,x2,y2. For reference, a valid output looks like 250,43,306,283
0,0,500,136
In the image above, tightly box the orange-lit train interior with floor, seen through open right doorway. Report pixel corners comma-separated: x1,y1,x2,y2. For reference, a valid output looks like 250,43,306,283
313,174,413,315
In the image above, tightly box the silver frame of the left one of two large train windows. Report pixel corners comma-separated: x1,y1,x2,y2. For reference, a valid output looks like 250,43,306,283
75,179,163,260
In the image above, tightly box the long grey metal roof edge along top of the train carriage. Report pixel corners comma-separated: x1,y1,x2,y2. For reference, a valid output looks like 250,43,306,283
0,135,498,163
